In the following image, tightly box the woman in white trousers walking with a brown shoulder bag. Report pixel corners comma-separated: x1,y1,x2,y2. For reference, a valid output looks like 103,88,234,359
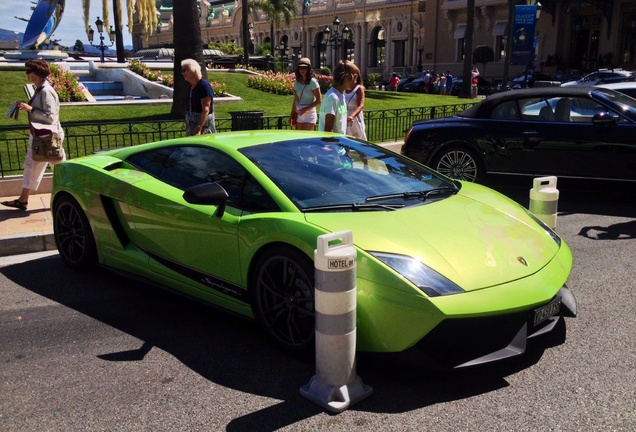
0,58,66,211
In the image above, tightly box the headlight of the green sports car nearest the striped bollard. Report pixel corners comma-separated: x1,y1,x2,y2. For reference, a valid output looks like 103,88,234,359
370,252,464,297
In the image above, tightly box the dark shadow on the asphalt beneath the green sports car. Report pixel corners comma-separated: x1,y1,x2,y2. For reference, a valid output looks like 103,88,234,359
0,256,565,431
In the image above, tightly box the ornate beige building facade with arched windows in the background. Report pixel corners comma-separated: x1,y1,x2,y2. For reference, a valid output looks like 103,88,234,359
133,0,636,78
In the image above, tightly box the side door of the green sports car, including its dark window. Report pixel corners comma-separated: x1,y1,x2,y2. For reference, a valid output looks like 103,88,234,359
122,145,246,289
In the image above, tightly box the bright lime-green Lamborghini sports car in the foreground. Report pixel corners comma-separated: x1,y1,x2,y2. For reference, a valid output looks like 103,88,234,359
51,131,576,367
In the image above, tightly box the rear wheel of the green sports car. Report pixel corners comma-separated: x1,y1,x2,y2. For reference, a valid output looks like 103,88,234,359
53,195,97,270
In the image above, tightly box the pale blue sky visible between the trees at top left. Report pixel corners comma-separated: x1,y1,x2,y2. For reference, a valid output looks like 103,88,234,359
0,0,132,47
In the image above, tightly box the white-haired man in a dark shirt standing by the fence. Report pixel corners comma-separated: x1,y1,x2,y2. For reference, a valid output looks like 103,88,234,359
181,59,216,136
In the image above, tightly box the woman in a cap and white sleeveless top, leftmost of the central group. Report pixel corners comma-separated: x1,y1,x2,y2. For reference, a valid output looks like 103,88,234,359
289,57,322,130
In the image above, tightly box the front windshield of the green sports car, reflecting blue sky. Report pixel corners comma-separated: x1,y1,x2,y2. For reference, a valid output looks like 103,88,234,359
240,136,459,211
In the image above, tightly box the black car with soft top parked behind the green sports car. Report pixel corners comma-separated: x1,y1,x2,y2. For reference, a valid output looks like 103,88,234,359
402,86,636,182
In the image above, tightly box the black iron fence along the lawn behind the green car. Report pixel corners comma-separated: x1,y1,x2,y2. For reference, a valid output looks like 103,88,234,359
0,102,474,178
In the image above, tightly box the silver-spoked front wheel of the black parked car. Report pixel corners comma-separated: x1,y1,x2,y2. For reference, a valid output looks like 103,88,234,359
431,146,485,183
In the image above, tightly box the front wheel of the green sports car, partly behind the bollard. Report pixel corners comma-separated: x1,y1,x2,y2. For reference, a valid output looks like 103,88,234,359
250,247,315,352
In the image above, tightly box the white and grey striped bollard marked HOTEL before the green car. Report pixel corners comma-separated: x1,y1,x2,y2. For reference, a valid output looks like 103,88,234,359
300,231,373,413
